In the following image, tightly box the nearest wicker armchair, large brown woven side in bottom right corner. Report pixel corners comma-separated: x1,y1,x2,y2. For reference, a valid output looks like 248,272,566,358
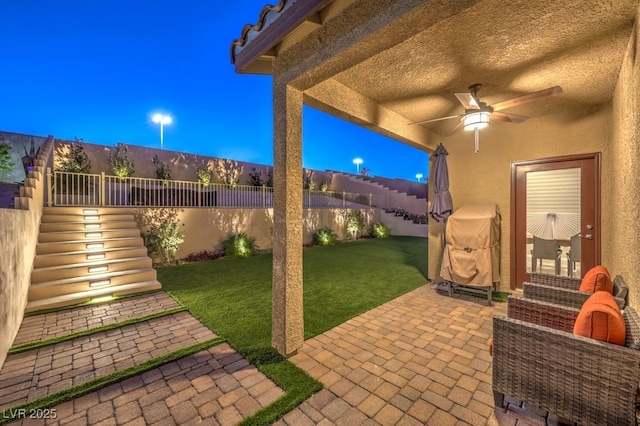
493,296,640,425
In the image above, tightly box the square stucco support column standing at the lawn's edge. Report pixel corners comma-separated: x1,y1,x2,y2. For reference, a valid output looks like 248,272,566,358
271,76,304,356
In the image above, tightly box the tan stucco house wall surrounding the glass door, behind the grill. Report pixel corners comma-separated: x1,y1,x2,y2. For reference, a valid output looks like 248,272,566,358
429,106,615,291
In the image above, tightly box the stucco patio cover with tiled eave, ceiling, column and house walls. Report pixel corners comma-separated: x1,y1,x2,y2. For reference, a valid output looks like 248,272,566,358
231,0,640,355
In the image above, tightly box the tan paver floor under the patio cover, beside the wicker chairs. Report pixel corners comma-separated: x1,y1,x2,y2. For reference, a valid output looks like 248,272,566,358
278,286,525,426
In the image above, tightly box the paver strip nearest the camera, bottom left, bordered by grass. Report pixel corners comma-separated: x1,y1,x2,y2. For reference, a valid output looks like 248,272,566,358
4,343,283,426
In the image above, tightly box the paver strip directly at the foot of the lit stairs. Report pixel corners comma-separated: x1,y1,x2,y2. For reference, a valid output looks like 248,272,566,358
13,291,180,345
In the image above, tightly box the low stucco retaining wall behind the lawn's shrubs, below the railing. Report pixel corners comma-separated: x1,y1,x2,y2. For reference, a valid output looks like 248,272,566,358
133,209,381,259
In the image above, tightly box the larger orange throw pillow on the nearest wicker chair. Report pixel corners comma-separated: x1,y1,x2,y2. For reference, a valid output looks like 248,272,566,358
573,291,627,346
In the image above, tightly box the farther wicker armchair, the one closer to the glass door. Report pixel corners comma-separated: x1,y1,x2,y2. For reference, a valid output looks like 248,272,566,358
522,274,629,309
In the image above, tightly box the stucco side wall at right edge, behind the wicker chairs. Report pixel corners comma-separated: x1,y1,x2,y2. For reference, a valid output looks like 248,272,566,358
602,18,640,309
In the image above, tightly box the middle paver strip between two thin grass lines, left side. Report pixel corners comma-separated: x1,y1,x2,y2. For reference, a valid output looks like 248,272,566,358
0,312,216,410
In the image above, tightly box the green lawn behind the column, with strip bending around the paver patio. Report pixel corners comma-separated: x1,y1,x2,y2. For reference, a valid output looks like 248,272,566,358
158,237,427,424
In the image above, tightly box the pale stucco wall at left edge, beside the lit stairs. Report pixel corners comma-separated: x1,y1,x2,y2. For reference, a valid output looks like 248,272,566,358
0,142,51,368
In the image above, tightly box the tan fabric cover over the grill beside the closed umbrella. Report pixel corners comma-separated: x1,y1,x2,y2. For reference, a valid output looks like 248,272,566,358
440,204,500,287
